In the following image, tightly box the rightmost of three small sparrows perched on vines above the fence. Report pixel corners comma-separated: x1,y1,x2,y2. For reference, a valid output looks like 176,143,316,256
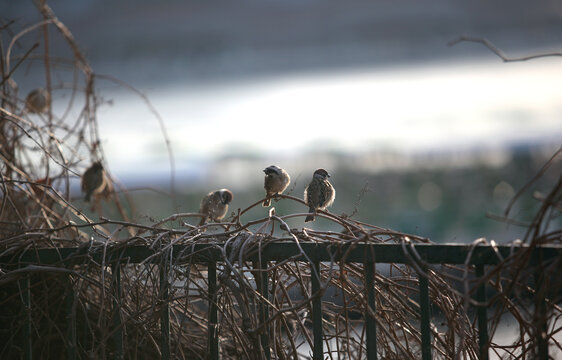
304,169,336,222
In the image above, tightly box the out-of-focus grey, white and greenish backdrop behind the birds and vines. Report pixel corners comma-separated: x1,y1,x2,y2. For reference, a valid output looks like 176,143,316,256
4,0,562,242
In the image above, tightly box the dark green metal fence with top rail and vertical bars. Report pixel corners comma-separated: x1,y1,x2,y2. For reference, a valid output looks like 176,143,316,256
0,242,562,360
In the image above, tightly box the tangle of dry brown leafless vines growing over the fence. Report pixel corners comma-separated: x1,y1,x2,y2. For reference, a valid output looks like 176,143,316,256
0,4,562,359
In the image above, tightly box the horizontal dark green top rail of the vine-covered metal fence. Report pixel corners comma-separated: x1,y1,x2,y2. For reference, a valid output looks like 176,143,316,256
0,242,562,267
